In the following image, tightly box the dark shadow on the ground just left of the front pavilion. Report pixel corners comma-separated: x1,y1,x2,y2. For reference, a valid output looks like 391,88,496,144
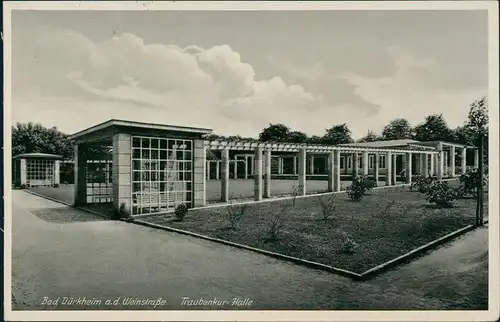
31,207,110,224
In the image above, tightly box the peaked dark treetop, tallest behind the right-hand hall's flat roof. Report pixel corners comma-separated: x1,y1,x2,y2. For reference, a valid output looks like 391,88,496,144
414,114,454,141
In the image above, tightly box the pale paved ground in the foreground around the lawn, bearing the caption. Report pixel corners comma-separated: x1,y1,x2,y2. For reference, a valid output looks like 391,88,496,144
12,191,488,310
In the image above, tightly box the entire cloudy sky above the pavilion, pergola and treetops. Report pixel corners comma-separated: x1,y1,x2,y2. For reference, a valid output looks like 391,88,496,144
11,10,488,138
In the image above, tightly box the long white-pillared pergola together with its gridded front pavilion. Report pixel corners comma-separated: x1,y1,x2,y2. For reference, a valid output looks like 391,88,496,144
71,120,476,216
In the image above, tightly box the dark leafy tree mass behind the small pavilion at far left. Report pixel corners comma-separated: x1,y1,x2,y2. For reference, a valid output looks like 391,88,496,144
12,122,73,159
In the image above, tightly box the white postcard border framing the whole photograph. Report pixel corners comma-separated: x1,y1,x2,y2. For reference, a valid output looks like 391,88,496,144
3,1,500,321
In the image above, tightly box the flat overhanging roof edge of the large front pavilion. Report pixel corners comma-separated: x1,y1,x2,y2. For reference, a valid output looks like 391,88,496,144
69,119,213,140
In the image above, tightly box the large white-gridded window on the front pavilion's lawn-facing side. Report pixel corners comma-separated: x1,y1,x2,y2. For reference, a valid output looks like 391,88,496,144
132,137,193,215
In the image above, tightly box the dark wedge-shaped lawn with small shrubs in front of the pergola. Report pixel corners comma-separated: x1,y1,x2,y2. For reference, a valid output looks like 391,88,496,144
142,182,488,273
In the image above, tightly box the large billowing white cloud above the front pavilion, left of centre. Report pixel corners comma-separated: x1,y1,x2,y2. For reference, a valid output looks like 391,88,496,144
14,27,332,135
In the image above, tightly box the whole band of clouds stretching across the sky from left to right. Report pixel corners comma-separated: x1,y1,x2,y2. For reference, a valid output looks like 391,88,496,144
12,20,485,137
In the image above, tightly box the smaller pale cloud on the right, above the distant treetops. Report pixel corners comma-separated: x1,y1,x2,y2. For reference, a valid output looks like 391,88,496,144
341,46,487,129
